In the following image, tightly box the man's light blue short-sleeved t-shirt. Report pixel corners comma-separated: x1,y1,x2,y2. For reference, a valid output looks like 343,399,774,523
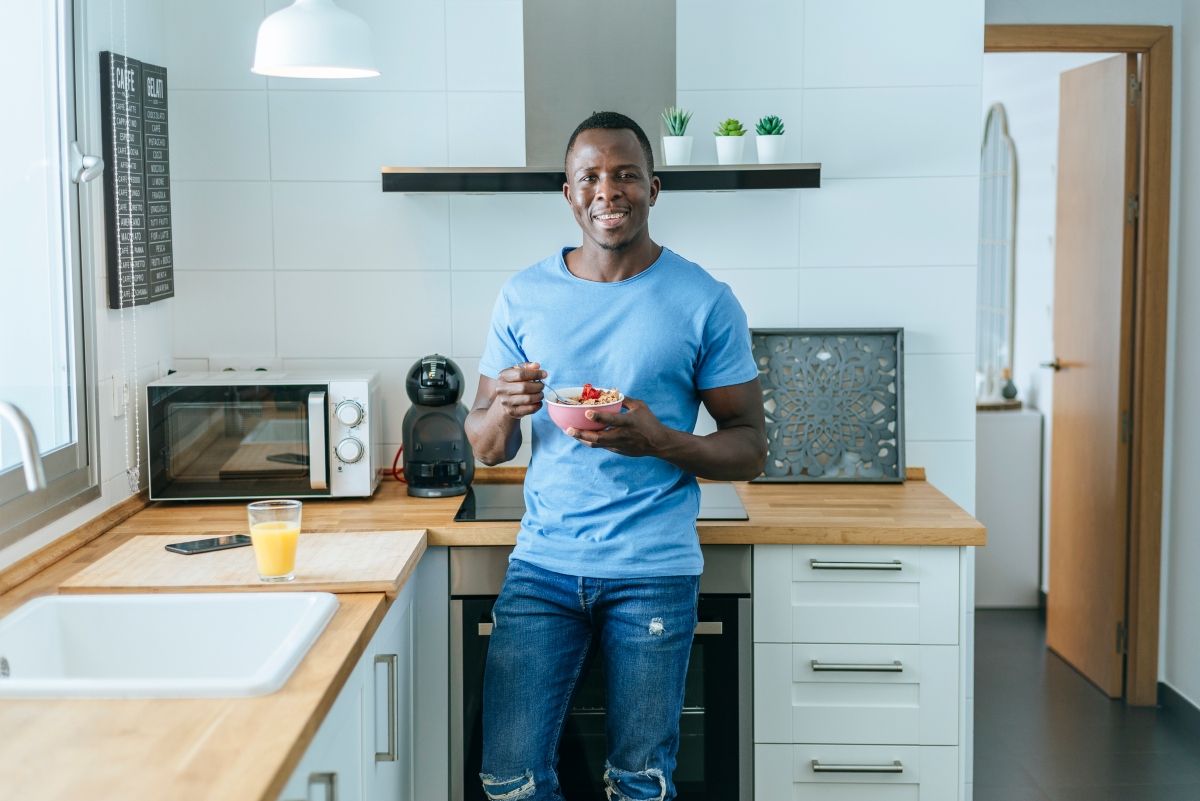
479,248,758,578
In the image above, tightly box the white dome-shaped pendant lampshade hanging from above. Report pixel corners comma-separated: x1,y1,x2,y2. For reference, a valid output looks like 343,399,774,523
251,0,379,78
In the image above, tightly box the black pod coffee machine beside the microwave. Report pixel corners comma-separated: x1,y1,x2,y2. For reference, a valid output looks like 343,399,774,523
403,354,475,498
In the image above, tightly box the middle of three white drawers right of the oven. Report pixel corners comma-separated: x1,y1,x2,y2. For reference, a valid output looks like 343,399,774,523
755,643,959,746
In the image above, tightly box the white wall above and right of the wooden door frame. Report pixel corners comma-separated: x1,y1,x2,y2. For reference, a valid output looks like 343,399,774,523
986,0,1200,705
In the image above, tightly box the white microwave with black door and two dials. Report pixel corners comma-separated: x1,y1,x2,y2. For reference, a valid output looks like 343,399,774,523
146,372,383,500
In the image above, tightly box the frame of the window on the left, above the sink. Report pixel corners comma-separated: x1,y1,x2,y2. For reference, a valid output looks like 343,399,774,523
0,0,107,548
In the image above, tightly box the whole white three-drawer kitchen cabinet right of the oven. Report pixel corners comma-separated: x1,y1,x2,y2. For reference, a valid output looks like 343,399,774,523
754,546,972,801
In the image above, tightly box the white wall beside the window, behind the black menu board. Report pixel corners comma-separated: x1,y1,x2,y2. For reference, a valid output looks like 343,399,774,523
0,0,174,567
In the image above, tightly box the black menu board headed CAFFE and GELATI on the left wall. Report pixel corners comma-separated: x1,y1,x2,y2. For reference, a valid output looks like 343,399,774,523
100,50,175,308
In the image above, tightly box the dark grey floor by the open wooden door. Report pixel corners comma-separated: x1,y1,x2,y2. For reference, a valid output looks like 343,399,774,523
974,610,1200,801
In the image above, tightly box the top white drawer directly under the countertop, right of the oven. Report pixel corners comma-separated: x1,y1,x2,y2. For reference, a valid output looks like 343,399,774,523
754,546,960,645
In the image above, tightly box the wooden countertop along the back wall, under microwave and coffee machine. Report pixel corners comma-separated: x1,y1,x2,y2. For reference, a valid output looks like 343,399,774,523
115,472,986,546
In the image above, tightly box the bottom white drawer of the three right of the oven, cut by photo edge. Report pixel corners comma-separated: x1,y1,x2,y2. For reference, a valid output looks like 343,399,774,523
755,745,959,801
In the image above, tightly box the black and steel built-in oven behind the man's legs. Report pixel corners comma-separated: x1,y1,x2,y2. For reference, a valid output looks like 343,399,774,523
450,546,754,801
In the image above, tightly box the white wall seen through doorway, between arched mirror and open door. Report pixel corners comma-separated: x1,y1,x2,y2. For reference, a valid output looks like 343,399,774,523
976,53,1112,591
